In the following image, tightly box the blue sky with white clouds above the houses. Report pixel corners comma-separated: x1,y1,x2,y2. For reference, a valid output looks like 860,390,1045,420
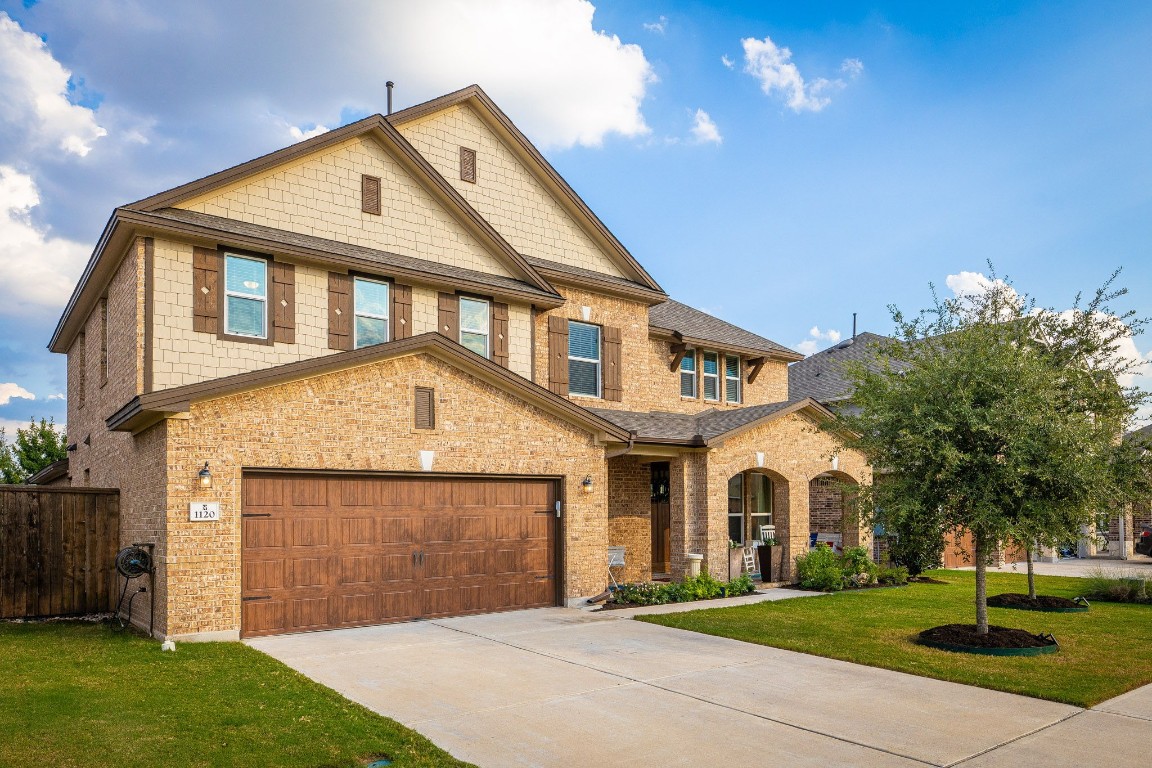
0,0,1152,434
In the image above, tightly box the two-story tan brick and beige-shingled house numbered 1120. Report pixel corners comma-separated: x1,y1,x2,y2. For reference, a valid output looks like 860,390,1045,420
51,86,870,639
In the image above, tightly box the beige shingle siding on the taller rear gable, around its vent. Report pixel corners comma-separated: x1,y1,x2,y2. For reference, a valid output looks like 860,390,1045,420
399,105,622,277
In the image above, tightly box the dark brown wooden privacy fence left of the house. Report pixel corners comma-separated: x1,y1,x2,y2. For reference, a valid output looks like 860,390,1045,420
0,486,120,618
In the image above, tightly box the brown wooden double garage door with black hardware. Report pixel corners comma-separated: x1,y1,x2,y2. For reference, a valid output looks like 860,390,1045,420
242,473,558,637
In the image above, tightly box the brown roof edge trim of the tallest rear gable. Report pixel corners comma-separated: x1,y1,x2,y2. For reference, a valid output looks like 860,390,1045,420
388,84,664,294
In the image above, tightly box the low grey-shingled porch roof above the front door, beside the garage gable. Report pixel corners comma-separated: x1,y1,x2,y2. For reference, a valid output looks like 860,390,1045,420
588,397,835,448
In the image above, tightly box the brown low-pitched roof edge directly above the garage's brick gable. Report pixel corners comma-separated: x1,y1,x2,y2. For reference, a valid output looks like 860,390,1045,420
105,333,629,441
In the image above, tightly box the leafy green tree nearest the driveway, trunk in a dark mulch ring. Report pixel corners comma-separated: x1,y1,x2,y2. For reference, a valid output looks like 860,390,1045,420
842,274,1147,633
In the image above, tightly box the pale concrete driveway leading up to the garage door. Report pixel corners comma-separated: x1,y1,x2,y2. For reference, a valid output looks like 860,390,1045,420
248,598,1152,768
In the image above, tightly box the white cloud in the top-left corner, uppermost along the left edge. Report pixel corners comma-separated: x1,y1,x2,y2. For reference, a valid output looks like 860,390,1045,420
0,12,107,160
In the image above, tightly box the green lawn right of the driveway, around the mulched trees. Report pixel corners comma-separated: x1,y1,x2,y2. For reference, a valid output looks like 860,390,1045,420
637,571,1152,707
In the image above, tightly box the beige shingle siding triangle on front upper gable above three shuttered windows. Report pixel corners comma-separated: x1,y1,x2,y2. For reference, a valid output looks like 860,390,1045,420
176,136,510,276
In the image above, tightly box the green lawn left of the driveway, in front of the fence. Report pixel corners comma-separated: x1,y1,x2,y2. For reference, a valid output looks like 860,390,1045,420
0,623,468,768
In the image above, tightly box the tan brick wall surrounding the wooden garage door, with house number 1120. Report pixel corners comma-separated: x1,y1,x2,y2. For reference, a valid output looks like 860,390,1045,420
162,355,608,636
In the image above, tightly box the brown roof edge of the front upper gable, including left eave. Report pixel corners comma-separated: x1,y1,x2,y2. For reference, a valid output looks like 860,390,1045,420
50,108,559,351
